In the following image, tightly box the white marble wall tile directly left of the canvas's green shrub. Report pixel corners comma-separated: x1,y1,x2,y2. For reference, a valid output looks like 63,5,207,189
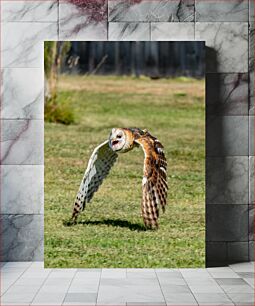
1,68,44,119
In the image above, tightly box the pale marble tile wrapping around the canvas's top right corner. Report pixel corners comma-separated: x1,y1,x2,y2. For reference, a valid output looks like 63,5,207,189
195,22,248,73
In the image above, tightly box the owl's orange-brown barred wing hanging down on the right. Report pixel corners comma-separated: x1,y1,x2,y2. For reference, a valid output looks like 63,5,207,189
135,135,168,228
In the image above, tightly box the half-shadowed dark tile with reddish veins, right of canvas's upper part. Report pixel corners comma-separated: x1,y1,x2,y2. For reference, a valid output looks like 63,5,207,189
206,73,248,116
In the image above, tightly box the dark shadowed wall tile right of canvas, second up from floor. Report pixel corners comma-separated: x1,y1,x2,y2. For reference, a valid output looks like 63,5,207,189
206,205,249,242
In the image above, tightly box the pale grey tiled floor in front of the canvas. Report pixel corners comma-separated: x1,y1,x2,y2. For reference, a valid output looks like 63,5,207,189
0,262,254,306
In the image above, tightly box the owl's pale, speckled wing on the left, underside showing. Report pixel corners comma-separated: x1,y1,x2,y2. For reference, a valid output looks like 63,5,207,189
72,140,118,221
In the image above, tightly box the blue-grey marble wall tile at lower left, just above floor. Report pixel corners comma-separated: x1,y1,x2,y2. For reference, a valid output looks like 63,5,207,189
0,215,43,261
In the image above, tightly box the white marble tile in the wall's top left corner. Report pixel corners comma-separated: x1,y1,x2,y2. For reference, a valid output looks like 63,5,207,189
1,0,58,22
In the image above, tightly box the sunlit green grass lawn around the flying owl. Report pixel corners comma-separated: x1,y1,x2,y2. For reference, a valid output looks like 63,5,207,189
44,76,205,268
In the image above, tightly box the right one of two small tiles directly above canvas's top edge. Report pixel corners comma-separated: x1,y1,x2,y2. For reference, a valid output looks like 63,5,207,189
151,22,195,41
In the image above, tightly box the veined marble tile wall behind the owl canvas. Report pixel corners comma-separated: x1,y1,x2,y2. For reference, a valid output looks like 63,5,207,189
0,0,254,266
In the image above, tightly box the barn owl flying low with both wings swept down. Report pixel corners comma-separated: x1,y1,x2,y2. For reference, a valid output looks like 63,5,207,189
72,128,168,228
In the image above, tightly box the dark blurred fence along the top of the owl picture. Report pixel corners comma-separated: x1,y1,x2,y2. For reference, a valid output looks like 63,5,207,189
62,41,205,78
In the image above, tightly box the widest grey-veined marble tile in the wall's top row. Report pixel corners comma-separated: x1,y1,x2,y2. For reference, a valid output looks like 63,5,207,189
108,0,195,22
